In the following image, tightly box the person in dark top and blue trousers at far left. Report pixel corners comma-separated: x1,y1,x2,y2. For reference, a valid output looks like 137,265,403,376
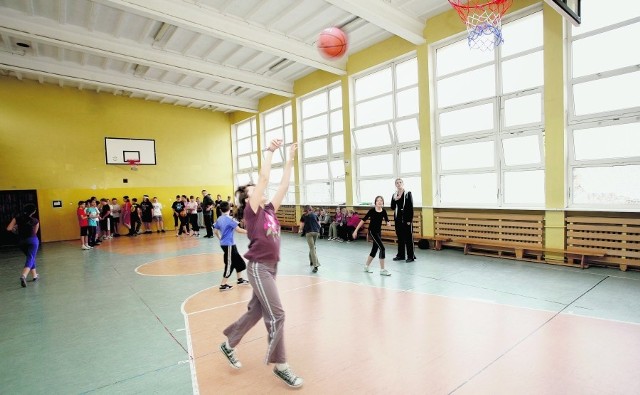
7,204,40,288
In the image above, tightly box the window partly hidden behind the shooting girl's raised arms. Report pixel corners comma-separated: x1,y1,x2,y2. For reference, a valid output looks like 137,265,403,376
261,104,296,204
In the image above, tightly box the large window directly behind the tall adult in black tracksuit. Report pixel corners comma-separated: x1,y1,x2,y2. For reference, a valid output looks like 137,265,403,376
352,56,422,206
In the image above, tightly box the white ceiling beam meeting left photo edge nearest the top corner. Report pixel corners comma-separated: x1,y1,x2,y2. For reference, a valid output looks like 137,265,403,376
0,12,293,97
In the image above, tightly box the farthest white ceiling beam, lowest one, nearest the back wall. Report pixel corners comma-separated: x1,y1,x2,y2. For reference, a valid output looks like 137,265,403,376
0,53,258,113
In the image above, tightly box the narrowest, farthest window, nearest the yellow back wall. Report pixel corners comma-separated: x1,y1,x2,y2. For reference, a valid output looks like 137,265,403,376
232,117,259,187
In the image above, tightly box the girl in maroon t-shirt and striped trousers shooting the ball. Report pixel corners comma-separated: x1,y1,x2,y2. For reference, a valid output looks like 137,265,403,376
220,139,303,387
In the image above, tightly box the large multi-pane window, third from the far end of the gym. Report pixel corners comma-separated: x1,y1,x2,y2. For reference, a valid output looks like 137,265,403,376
299,86,346,204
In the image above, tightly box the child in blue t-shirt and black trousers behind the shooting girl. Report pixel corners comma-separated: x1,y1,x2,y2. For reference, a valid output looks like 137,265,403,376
213,202,249,291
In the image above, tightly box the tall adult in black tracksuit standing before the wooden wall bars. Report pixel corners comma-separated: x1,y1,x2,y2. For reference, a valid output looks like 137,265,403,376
391,178,416,262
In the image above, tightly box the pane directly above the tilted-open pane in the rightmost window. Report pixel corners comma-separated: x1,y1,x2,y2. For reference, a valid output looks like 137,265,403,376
573,71,640,115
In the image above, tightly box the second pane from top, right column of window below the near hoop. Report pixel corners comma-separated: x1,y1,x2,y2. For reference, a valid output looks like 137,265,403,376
502,51,544,93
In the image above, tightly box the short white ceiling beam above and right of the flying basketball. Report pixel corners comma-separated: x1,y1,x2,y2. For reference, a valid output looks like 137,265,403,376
325,0,426,45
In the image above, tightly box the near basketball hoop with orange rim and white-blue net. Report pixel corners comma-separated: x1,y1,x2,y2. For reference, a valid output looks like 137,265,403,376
449,0,513,51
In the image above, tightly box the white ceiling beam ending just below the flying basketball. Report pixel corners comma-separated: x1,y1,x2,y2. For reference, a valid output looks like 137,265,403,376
94,0,346,75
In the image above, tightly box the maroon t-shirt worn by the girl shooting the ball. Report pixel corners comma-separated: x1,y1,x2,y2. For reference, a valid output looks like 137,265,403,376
244,203,280,265
